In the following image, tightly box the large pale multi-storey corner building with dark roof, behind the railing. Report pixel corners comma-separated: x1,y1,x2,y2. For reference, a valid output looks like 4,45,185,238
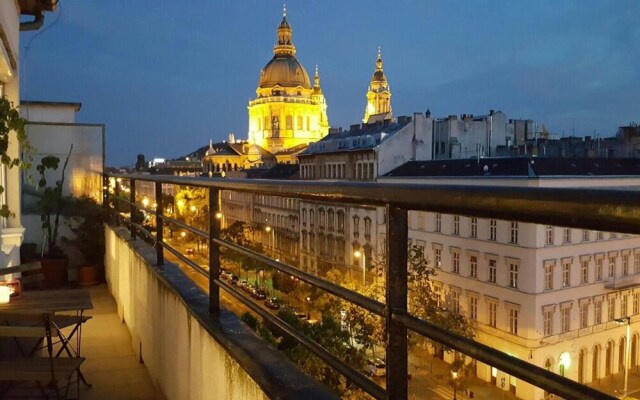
379,157,640,400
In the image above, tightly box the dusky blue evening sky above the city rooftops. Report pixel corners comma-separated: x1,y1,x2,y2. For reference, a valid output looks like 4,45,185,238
21,0,640,165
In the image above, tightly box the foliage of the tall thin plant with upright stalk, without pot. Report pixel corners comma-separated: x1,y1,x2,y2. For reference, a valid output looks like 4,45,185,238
36,144,73,257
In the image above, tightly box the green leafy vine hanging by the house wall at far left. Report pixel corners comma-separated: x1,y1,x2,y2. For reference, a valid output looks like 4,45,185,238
0,97,31,218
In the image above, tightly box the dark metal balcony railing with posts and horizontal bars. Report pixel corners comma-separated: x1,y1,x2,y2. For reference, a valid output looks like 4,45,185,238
105,174,640,400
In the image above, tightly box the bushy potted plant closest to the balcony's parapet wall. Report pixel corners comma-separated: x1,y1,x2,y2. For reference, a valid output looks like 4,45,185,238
63,196,105,285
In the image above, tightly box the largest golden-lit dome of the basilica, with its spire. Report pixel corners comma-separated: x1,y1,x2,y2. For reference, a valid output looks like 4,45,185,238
247,8,329,154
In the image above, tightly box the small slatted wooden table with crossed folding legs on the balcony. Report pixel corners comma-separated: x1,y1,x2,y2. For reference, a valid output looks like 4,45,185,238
0,289,93,386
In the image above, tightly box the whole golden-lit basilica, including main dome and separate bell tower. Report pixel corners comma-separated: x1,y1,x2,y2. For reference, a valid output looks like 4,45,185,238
203,9,392,173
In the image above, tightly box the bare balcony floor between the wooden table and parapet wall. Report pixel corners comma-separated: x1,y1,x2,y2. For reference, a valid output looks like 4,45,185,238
80,284,165,400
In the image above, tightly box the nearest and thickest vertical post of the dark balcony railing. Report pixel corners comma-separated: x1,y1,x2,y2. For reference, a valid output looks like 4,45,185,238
385,205,409,400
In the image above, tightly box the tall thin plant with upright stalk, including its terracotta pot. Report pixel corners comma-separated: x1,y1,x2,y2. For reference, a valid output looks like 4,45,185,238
36,145,73,288
